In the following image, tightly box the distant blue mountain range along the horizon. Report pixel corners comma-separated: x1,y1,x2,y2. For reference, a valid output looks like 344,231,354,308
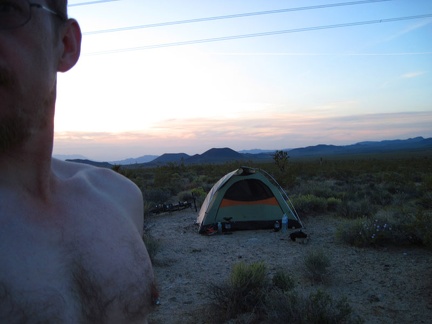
66,137,432,167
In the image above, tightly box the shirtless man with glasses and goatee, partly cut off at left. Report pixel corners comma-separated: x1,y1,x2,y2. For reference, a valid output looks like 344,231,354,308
0,0,154,324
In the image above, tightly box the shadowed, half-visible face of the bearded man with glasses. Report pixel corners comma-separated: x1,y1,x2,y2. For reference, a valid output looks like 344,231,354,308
0,0,61,153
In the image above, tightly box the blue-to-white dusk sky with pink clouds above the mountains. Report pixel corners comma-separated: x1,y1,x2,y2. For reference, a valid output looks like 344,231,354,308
53,0,432,161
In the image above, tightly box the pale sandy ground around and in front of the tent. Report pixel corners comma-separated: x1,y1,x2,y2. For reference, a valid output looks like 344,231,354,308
146,209,432,324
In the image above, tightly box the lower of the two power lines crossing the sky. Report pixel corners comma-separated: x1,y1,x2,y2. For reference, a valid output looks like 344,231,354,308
84,14,432,56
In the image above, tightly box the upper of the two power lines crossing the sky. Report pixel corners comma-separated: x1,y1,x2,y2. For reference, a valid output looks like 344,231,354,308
83,0,393,35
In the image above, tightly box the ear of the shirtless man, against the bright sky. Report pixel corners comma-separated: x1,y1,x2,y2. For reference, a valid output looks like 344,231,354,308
57,19,81,72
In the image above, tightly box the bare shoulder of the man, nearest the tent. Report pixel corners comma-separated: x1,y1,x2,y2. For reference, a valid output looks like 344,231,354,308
51,159,143,233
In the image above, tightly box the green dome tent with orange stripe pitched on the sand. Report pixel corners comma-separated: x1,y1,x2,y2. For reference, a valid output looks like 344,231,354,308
197,167,303,233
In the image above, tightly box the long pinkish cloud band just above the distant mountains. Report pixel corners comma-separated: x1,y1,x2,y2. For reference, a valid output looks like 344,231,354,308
54,111,432,161
